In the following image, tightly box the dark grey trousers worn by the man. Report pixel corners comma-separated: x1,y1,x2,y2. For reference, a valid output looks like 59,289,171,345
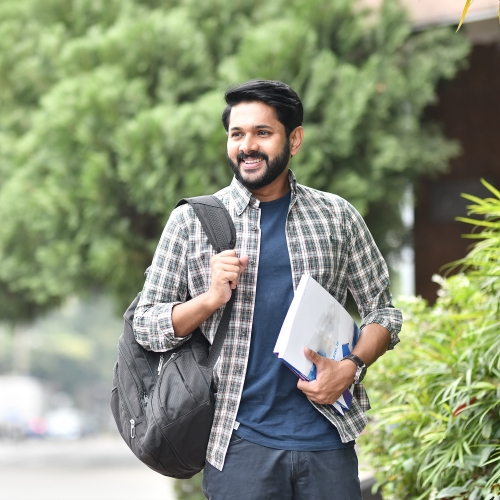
203,434,361,500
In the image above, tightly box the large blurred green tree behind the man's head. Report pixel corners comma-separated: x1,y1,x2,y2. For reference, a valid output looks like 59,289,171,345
0,0,468,312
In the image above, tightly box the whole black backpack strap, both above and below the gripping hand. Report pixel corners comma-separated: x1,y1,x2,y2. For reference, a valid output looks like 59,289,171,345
176,196,236,369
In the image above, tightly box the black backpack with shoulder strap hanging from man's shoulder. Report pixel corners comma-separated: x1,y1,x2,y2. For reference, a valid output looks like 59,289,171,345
111,196,236,479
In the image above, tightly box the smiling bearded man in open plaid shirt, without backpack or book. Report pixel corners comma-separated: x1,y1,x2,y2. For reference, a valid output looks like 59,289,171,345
134,81,401,500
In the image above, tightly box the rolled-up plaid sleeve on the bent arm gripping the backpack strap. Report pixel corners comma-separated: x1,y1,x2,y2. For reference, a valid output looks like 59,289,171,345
134,207,189,351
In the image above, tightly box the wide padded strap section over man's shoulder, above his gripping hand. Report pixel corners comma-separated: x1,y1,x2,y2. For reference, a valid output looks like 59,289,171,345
176,196,236,253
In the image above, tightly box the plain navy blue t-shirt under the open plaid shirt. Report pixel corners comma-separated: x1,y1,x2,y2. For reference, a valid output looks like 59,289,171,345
235,192,354,451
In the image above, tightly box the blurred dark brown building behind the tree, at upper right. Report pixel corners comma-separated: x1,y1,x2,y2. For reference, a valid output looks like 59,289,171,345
407,0,500,303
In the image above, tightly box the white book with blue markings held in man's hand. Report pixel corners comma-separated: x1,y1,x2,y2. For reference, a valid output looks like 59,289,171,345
274,275,359,415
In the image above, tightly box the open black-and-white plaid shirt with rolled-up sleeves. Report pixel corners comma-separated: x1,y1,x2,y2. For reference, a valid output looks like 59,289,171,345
134,172,402,470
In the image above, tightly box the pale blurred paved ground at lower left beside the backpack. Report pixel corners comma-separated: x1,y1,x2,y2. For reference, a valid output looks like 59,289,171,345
0,437,175,500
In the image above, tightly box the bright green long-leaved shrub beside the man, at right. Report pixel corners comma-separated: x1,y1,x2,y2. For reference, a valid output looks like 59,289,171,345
365,182,500,500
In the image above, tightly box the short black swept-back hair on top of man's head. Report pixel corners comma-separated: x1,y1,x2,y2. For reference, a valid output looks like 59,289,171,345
222,80,304,137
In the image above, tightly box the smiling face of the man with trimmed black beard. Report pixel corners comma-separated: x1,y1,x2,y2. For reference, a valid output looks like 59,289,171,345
227,102,290,190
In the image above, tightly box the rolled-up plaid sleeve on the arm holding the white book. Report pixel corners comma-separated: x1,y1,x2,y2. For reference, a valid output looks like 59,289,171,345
347,204,403,349
